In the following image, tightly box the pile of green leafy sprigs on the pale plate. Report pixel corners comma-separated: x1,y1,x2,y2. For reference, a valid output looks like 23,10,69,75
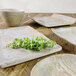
7,37,56,51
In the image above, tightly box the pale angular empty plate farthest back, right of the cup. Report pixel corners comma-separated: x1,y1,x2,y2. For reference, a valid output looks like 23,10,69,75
32,14,76,27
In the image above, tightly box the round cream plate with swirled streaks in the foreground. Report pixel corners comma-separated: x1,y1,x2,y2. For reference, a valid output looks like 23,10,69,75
31,54,76,76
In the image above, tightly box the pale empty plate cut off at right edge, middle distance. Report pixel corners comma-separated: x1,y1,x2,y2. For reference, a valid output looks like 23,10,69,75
52,27,76,46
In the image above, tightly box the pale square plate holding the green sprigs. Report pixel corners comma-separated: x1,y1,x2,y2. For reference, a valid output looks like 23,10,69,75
0,26,62,68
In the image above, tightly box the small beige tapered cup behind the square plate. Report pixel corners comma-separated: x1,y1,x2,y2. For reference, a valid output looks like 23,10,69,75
0,9,24,26
